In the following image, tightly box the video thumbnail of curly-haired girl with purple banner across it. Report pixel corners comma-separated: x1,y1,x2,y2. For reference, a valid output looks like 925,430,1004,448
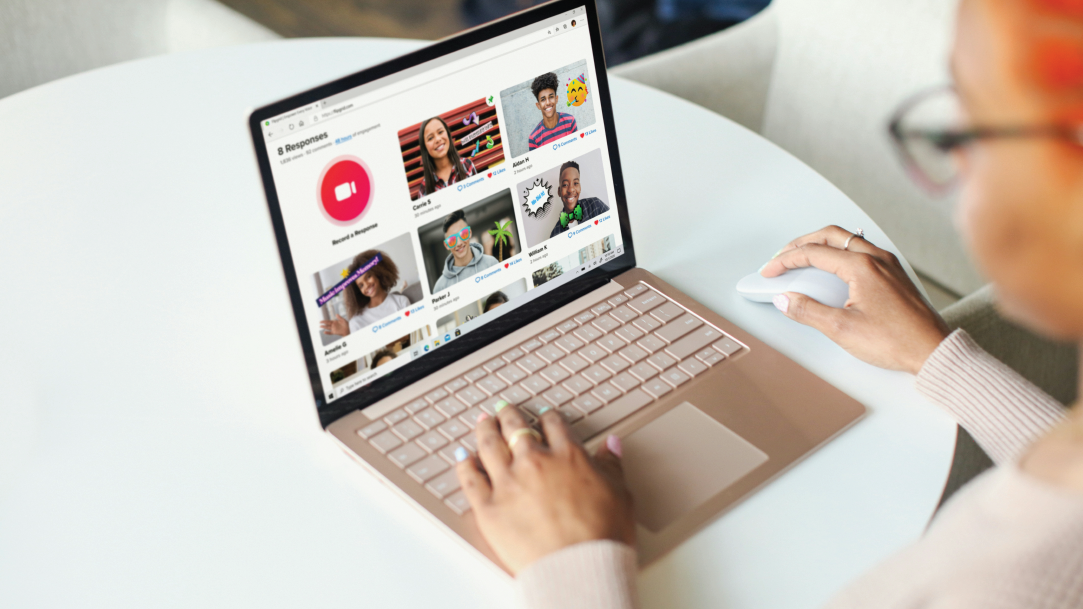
312,233,425,346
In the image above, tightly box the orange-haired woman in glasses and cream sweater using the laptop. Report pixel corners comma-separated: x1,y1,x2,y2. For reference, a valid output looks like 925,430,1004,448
457,0,1083,609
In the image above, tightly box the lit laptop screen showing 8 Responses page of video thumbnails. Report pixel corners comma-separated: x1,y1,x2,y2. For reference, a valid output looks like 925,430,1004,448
253,4,625,422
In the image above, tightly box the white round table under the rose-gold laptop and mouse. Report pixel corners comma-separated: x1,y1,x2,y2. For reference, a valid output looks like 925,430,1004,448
0,39,955,609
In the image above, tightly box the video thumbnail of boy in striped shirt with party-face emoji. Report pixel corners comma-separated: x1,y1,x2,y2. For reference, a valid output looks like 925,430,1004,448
500,60,595,157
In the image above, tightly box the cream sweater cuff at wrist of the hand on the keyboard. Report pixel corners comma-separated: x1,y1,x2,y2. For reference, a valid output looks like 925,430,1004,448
516,541,639,609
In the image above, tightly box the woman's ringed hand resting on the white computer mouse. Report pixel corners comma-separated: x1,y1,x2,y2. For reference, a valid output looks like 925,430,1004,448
760,226,951,374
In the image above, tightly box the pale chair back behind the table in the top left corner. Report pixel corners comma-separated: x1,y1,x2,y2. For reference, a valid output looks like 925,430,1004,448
0,0,278,98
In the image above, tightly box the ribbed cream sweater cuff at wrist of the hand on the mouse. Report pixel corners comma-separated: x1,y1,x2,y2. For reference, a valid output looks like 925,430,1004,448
917,329,1066,465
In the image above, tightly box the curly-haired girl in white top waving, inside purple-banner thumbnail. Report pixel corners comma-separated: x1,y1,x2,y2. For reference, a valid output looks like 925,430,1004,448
319,249,410,336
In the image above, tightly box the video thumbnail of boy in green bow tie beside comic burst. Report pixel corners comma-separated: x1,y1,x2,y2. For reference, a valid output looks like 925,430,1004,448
516,150,610,248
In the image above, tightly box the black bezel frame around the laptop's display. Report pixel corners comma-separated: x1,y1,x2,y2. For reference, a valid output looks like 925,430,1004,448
248,0,636,428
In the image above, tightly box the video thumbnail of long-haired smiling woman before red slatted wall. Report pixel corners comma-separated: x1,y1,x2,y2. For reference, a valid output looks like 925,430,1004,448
399,98,504,199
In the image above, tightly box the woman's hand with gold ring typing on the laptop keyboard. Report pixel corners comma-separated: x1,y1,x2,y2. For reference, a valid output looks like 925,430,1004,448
450,406,636,573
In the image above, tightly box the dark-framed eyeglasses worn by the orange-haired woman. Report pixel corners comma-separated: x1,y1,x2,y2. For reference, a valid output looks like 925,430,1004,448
888,86,1083,194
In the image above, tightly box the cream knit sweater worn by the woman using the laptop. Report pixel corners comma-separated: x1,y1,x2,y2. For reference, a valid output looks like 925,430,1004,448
517,331,1083,609
